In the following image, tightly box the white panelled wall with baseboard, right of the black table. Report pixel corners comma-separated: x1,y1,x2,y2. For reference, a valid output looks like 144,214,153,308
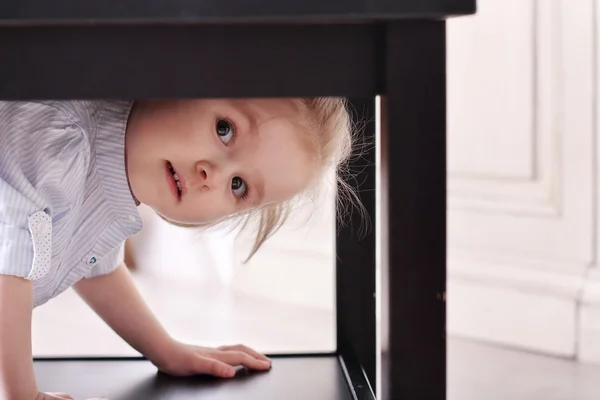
448,0,600,362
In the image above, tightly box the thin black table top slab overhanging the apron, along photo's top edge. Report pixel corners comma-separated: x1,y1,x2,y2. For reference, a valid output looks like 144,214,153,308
0,0,475,25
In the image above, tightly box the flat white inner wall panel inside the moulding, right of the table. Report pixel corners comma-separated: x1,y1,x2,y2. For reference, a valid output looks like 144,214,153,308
448,0,535,179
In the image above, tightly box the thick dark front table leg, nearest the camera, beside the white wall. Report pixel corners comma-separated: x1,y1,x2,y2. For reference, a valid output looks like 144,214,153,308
378,21,446,400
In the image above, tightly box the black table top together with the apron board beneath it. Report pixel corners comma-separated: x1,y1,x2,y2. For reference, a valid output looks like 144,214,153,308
0,0,475,100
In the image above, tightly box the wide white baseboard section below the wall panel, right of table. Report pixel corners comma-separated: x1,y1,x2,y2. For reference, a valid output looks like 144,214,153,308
447,255,588,357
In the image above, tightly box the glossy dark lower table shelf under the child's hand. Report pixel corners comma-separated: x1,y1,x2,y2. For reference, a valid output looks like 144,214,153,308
34,354,374,400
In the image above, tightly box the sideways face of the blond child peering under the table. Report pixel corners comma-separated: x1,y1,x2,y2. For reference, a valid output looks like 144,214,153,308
125,99,313,224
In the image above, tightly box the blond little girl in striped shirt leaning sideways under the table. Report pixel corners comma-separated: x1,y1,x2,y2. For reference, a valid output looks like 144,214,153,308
0,98,351,400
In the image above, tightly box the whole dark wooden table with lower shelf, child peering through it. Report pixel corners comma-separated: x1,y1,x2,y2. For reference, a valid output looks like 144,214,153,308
0,0,475,400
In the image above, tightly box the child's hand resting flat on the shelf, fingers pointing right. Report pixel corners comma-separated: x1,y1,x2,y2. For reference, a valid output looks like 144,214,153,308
154,342,271,378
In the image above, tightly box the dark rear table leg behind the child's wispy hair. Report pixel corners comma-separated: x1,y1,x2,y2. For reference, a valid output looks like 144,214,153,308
336,98,376,398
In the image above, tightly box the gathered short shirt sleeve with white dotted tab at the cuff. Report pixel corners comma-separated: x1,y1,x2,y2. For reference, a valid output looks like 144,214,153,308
0,101,89,280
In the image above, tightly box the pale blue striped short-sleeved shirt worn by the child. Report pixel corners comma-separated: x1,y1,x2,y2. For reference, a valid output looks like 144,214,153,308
0,101,142,307
